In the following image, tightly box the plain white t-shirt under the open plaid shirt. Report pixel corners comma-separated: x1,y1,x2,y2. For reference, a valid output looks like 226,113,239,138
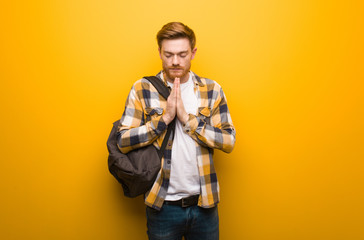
162,73,200,201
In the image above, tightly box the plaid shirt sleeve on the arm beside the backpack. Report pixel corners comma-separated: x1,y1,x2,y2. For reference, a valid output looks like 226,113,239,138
117,82,167,154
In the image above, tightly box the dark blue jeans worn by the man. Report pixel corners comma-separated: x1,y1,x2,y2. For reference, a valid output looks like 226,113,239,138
146,204,219,240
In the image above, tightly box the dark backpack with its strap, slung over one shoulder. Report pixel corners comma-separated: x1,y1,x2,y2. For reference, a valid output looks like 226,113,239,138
107,76,175,197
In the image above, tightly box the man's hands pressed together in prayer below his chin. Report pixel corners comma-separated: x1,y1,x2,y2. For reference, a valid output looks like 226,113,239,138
162,78,188,125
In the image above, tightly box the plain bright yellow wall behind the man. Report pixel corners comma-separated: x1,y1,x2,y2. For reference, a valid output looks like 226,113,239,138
0,0,364,240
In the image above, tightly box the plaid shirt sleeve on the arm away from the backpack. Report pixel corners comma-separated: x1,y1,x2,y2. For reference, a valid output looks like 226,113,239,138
184,87,236,153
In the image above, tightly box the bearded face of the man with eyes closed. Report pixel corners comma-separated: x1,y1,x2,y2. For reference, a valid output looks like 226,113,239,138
159,38,197,83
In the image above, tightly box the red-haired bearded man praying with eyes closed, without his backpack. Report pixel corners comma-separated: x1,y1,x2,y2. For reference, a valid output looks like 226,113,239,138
118,22,235,240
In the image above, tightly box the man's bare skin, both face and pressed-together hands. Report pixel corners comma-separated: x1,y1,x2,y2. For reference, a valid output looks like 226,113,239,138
158,38,197,125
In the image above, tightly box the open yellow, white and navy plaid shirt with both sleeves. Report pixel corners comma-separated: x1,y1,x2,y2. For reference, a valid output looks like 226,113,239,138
118,71,235,210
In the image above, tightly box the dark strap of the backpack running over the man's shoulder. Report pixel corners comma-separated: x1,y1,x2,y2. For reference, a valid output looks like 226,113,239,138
143,76,176,158
